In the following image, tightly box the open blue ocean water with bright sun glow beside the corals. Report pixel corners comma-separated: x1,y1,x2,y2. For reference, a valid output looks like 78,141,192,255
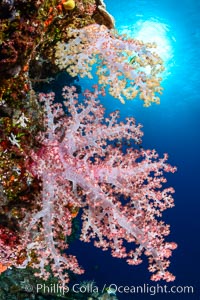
69,0,200,300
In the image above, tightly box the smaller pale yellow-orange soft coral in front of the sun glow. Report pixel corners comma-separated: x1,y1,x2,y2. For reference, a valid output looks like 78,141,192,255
56,24,163,106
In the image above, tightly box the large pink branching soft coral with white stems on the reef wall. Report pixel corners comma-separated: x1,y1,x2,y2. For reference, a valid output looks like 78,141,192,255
17,86,176,281
